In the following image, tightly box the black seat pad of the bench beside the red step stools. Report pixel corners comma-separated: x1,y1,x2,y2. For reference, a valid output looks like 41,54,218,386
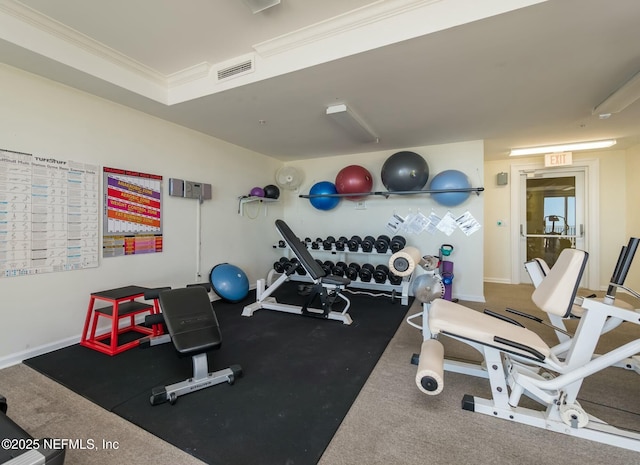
159,287,222,355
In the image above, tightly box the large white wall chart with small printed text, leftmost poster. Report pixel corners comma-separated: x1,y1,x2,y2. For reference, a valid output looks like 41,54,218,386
0,149,100,278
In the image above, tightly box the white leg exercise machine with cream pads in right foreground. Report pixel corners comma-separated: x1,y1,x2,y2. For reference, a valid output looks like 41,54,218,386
416,245,640,452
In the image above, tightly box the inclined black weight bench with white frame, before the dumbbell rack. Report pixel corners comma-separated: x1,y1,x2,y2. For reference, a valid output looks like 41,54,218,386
242,220,352,325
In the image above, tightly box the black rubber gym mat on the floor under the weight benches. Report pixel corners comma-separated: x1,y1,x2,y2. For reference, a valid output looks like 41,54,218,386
25,284,407,465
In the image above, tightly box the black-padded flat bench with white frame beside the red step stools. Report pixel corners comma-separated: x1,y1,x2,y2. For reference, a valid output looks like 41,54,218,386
140,285,242,405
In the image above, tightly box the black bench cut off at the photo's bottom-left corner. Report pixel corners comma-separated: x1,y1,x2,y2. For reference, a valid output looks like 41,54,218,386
0,395,66,465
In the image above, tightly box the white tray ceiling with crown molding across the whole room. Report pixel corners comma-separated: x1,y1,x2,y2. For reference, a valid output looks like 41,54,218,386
0,0,640,160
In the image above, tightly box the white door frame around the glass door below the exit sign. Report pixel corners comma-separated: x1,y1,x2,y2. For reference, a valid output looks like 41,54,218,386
511,159,600,290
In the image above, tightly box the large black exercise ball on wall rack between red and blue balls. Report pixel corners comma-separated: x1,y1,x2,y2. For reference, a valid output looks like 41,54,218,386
380,151,429,191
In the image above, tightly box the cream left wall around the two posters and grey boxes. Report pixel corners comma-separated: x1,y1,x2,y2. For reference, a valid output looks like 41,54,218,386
0,65,283,367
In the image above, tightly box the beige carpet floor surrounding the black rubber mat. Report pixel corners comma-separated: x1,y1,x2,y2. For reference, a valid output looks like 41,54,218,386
0,284,640,465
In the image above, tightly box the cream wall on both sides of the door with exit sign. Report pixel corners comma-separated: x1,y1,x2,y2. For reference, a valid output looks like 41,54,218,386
484,149,639,289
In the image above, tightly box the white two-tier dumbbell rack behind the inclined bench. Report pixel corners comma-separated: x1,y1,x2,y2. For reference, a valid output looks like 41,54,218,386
267,243,414,305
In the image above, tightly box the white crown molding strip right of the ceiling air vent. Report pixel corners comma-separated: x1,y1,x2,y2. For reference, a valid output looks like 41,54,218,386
253,0,443,58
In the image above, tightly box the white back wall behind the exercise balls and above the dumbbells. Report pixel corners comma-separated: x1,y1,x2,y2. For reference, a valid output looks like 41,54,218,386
285,141,485,301
